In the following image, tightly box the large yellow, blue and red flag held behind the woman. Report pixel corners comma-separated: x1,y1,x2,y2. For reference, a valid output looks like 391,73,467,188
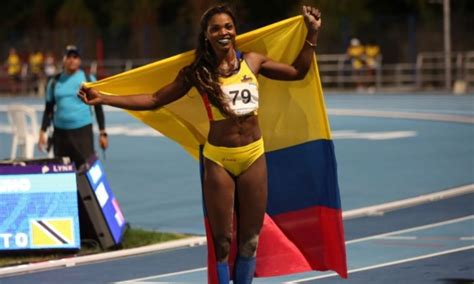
89,16,347,283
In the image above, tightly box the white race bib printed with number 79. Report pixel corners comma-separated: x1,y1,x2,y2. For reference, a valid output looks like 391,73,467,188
222,83,258,115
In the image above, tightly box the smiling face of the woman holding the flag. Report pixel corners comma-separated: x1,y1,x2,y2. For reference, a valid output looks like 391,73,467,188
206,13,236,53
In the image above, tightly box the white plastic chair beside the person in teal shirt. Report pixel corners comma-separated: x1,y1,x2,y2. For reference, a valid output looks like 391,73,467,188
7,105,39,160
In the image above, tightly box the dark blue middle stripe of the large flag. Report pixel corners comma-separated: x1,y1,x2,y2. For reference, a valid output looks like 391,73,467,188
266,140,341,216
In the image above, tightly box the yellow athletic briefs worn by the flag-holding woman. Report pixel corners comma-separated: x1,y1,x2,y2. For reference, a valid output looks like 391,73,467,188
203,138,265,176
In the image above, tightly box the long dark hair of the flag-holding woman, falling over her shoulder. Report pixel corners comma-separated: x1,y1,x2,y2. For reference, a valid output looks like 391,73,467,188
185,5,236,118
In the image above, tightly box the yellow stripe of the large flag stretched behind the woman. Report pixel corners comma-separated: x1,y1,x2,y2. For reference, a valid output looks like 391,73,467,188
84,16,331,159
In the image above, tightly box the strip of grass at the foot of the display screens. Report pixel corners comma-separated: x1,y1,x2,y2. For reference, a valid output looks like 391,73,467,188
0,228,189,267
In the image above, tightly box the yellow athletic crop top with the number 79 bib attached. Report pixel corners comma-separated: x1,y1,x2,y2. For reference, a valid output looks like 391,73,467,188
202,56,258,121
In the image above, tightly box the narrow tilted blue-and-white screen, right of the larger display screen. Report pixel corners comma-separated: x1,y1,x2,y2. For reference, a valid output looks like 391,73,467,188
86,159,126,244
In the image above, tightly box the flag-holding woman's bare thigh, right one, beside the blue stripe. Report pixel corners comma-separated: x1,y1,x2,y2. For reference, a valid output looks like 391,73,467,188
236,155,268,236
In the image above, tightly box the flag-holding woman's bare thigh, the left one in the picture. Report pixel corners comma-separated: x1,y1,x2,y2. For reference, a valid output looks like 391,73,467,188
203,158,235,237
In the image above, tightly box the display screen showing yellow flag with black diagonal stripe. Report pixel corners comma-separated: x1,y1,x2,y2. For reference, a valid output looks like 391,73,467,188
0,164,81,250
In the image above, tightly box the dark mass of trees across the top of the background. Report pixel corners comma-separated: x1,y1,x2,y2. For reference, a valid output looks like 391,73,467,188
0,0,474,62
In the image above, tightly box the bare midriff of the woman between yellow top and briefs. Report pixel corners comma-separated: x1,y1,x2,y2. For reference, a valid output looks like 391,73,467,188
208,115,262,147
